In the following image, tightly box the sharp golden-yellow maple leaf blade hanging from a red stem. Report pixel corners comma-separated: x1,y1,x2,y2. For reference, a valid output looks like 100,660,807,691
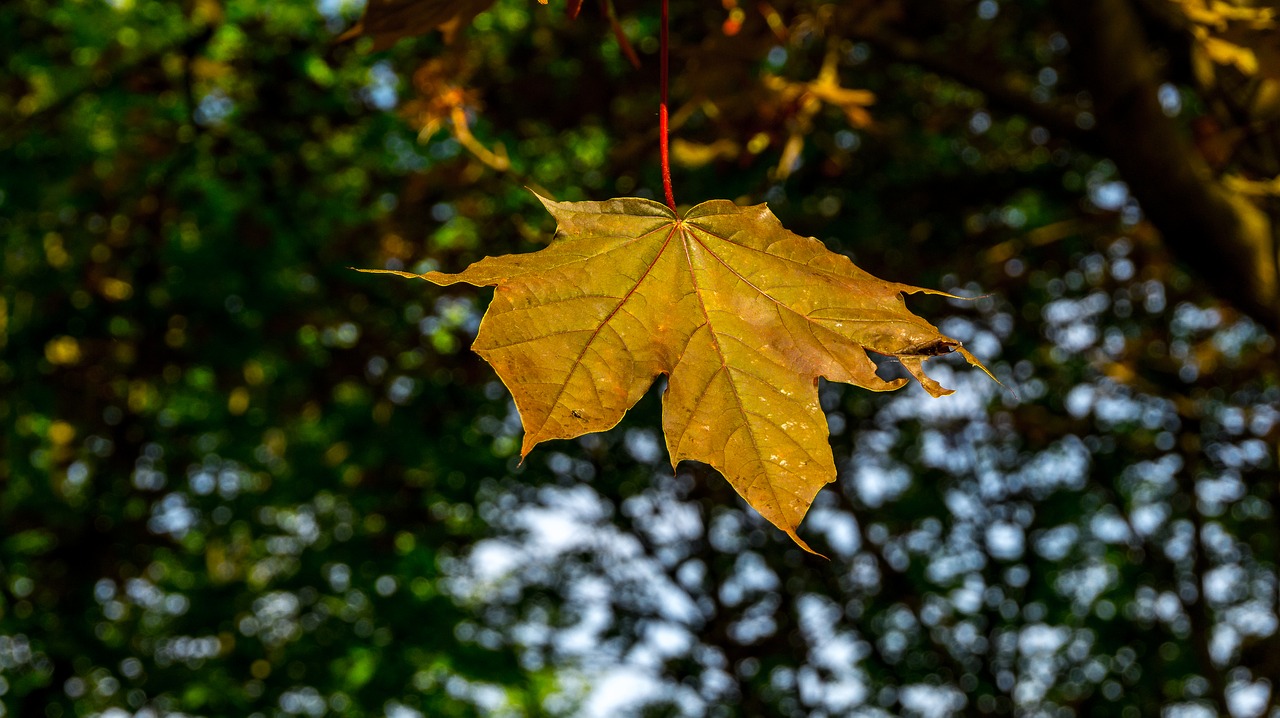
364,197,989,552
